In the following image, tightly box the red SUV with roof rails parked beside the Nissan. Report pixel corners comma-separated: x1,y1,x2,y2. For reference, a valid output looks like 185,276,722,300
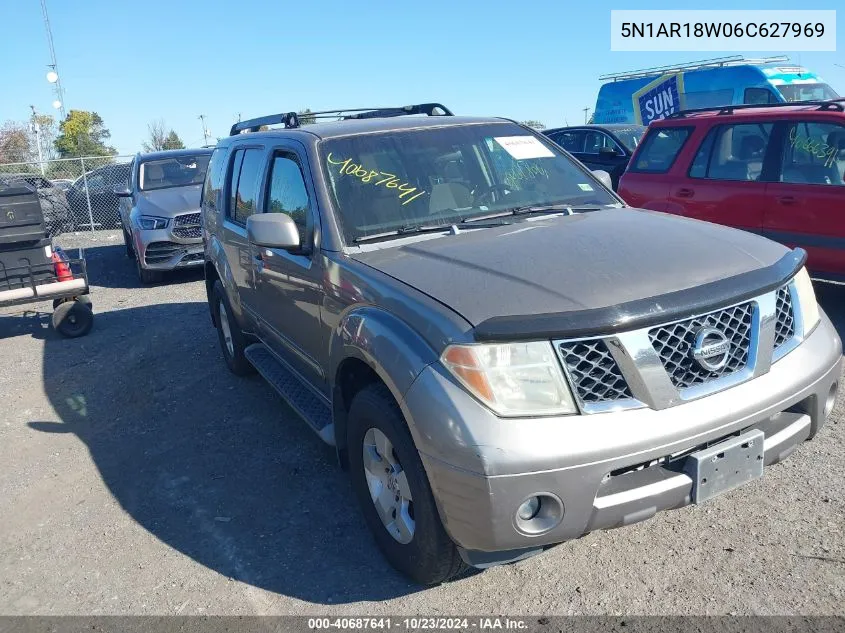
619,99,845,281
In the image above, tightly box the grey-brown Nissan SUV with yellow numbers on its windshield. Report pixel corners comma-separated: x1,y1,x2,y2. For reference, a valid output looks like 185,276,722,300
202,104,842,584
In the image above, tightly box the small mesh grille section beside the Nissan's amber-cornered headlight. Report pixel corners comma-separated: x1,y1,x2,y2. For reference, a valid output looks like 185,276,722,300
558,339,633,404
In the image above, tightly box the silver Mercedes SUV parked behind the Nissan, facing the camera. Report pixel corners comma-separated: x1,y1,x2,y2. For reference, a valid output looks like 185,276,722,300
114,149,211,284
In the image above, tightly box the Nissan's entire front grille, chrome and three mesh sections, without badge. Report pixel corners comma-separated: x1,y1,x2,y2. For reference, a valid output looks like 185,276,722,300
553,281,804,414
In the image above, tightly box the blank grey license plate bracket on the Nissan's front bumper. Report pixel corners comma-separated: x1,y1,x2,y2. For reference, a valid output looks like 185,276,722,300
684,430,765,503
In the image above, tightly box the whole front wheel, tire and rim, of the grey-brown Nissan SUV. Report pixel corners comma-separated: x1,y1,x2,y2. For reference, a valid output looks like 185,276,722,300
347,384,466,585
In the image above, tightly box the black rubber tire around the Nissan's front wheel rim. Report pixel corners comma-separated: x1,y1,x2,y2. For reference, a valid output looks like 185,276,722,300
347,383,466,585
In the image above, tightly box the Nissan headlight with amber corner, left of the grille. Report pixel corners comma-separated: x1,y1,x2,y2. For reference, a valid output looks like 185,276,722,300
440,341,577,416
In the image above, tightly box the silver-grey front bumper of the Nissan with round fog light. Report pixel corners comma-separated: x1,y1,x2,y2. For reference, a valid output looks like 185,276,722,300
402,314,842,566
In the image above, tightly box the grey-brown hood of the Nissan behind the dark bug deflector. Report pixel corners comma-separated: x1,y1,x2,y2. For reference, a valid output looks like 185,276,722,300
350,208,789,326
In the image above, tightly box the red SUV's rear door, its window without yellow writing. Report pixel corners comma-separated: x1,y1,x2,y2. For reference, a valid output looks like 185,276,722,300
668,121,773,232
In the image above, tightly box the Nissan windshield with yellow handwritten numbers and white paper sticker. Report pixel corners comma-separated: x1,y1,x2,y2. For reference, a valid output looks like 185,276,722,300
320,123,618,242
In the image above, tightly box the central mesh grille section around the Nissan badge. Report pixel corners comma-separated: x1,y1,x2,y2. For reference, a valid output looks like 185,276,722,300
648,302,754,389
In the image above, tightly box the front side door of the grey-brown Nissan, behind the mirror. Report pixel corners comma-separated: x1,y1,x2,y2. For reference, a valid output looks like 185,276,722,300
253,144,328,395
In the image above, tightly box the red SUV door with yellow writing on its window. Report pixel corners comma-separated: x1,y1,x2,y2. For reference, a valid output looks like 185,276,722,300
763,118,845,280
